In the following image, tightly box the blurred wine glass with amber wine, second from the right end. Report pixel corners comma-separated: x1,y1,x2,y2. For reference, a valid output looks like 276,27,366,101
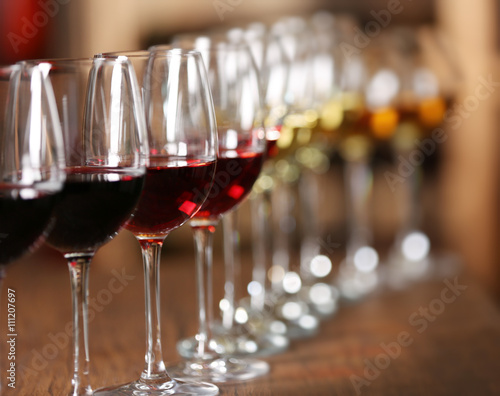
338,35,400,300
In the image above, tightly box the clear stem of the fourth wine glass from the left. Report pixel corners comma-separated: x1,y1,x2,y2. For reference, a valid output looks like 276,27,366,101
191,222,217,359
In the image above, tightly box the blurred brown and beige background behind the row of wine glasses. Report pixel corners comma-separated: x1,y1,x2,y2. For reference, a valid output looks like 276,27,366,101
0,0,500,301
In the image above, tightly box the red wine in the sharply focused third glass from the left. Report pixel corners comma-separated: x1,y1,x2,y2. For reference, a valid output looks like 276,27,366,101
127,157,215,237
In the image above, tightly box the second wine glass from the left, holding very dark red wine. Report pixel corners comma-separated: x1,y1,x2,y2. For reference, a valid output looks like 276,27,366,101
22,58,148,395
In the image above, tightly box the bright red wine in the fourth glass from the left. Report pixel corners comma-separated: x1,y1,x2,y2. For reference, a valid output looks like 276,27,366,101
195,150,263,218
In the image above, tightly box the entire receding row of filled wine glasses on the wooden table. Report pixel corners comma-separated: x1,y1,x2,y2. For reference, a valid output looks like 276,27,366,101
0,9,458,395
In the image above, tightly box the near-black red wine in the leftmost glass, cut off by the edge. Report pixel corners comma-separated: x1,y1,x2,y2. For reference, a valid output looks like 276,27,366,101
0,185,57,264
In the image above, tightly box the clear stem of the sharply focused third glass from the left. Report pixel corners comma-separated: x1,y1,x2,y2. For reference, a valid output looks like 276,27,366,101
139,237,169,382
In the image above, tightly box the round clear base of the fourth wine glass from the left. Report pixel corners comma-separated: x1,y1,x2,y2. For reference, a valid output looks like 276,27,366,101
168,357,269,383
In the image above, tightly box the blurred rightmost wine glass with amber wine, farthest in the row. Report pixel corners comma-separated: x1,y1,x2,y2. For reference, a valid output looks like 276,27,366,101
389,27,460,286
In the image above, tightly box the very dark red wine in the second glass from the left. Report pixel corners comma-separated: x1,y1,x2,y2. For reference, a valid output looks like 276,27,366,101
48,167,145,253
